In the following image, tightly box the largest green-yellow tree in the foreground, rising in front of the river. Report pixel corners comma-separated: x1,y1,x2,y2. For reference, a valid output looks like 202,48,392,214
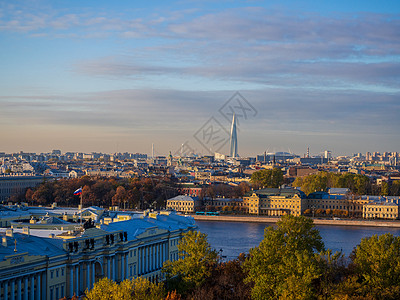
243,215,324,299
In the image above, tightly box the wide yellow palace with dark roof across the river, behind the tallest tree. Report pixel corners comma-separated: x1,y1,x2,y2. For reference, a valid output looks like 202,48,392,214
243,188,307,216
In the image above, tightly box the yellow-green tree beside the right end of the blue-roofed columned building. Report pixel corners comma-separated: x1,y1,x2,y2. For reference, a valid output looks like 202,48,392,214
164,231,218,293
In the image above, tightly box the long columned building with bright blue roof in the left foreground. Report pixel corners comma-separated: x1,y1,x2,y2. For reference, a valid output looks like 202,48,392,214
0,212,196,300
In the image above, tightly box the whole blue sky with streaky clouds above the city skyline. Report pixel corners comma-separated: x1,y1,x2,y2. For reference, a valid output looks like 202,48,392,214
0,0,400,156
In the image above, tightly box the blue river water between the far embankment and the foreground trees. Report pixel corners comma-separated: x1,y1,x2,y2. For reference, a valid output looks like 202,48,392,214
196,220,400,260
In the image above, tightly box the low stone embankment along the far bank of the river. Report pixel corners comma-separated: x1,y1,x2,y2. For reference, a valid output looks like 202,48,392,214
191,215,400,228
